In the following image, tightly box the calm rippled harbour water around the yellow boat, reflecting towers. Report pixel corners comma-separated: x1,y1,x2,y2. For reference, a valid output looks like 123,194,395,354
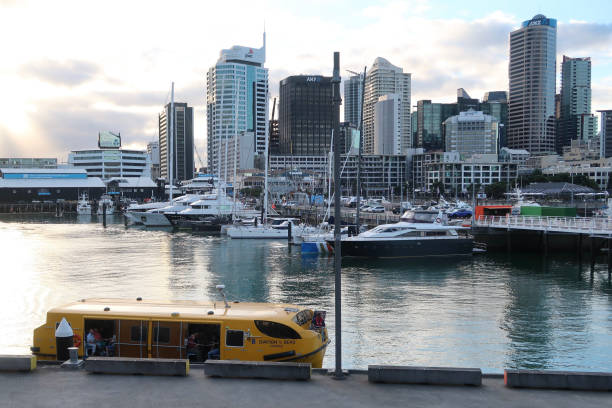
0,216,612,372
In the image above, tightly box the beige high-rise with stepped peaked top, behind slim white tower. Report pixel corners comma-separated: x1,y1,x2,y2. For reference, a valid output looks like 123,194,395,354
363,57,412,154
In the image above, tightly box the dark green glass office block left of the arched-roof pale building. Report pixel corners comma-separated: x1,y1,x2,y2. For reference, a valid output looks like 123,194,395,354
415,100,459,152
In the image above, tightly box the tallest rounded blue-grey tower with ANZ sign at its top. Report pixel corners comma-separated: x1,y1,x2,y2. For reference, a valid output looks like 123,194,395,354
508,14,557,154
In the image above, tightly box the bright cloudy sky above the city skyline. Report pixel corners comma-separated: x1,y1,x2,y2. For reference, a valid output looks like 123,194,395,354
0,0,612,163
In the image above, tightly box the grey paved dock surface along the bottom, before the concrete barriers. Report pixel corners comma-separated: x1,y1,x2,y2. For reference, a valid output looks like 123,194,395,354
0,366,612,408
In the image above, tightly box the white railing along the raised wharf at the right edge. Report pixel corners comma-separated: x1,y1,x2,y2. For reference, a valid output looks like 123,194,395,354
472,215,612,235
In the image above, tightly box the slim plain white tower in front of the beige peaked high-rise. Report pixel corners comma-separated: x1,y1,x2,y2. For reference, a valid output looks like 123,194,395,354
374,94,402,154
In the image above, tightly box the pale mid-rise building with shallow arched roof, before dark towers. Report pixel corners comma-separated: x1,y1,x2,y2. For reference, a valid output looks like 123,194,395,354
444,109,498,158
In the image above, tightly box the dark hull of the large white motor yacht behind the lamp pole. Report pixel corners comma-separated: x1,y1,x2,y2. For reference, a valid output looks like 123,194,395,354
328,238,474,259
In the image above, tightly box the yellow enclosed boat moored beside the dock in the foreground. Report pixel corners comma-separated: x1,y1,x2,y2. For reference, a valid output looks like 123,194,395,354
31,298,329,368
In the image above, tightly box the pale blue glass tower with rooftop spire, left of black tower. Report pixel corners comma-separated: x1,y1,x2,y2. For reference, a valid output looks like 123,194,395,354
206,33,268,176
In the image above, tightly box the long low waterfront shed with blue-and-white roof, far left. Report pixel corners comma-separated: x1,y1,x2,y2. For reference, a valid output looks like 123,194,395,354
0,168,106,203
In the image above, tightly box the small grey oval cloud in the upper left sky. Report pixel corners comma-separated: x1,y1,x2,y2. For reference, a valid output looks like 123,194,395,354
21,60,100,86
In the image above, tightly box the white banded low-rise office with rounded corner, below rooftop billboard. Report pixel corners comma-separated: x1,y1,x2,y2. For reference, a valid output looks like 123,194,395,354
68,149,151,180
